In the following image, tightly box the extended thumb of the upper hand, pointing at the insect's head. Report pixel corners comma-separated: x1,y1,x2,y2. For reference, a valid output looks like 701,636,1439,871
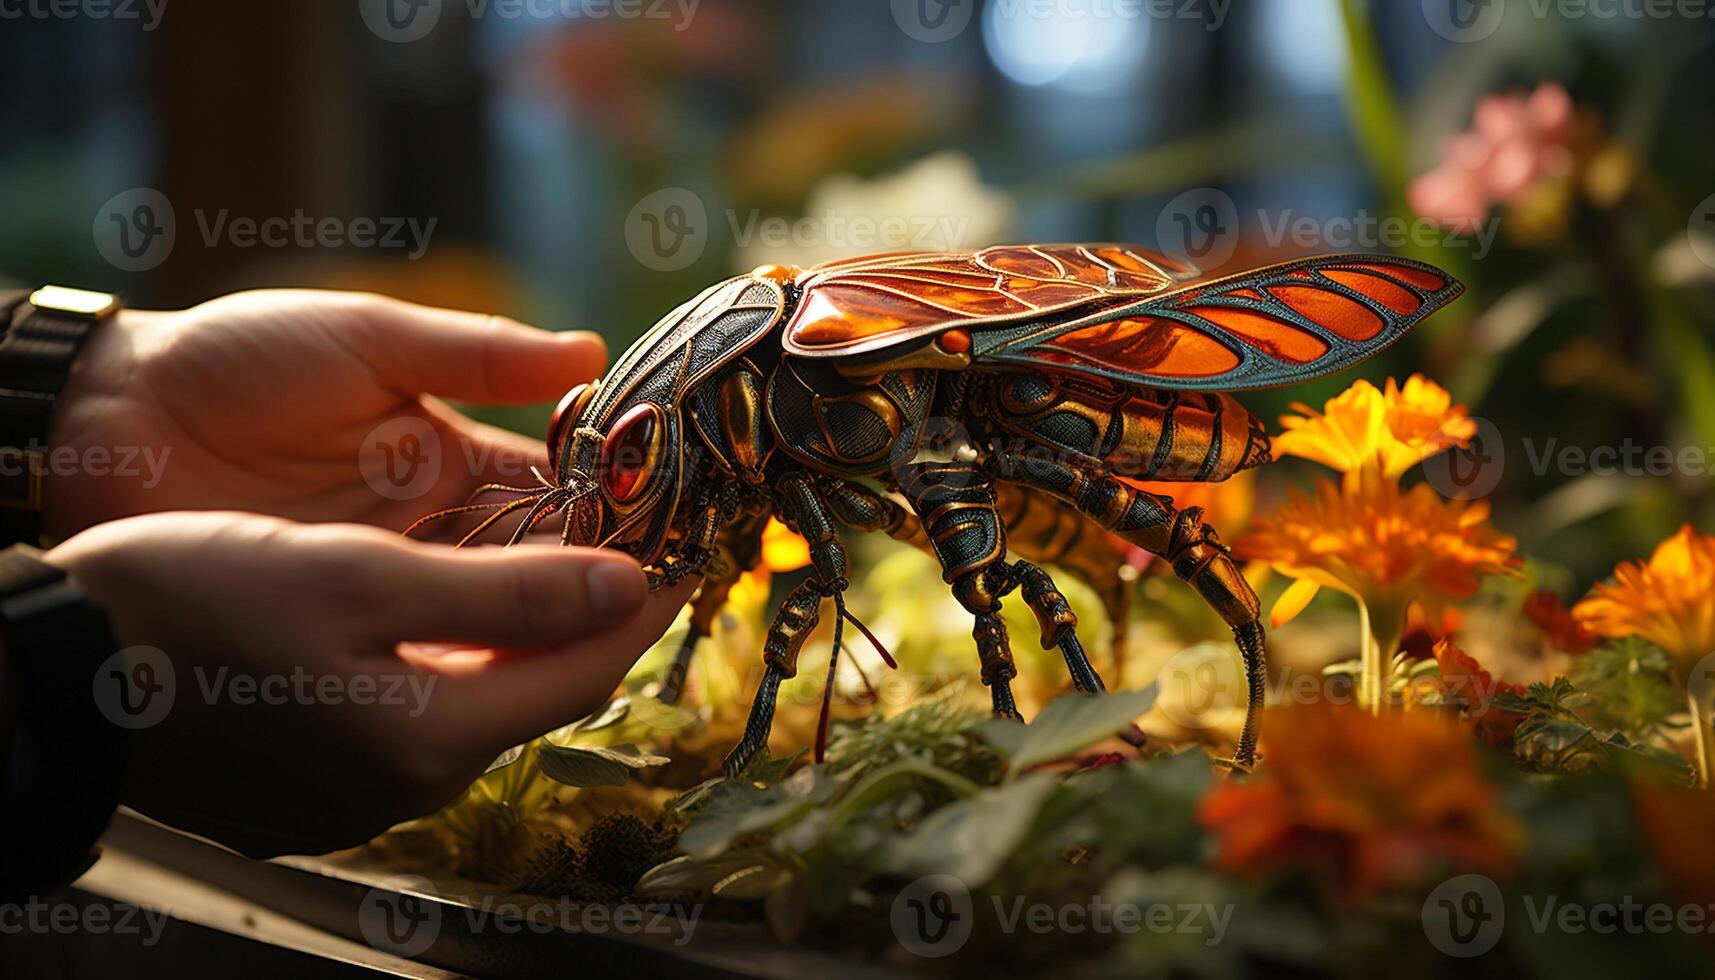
367,300,607,405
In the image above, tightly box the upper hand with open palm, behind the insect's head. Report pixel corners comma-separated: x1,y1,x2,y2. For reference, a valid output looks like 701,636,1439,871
43,290,605,539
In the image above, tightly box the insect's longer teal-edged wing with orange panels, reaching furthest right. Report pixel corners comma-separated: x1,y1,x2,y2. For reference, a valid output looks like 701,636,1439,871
972,256,1463,390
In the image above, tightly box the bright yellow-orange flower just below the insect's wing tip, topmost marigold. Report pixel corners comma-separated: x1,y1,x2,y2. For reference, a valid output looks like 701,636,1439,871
1274,374,1477,479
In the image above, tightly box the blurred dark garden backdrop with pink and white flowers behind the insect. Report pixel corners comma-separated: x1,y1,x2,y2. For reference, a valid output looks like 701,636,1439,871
0,0,1715,592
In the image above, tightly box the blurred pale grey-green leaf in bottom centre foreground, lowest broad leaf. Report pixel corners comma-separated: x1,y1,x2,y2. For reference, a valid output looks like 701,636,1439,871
888,772,1060,887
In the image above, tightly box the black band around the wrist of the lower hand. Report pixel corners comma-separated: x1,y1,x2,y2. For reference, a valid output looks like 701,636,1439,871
0,544,129,901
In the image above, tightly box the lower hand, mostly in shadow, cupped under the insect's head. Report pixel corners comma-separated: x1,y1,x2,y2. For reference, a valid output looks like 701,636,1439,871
46,513,691,856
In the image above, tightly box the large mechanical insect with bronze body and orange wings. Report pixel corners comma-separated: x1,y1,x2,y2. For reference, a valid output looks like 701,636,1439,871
411,244,1461,774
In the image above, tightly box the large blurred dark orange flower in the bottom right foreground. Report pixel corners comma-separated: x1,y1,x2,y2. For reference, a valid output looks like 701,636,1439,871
1197,704,1521,899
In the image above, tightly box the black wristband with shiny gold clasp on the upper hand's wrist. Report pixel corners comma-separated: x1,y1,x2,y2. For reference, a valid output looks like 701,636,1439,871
0,287,120,544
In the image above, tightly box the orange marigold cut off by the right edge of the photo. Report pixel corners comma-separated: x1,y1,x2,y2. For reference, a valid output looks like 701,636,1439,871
1573,523,1715,675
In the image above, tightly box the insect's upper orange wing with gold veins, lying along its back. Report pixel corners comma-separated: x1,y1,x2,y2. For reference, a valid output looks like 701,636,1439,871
784,245,1195,357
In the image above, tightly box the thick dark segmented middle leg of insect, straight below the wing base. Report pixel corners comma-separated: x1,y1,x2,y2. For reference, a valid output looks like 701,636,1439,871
899,462,1019,717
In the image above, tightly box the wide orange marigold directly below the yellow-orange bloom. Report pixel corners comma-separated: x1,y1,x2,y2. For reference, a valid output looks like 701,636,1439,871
1238,469,1519,621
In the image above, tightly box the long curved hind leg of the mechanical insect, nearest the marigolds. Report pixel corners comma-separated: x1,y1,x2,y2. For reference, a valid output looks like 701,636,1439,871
990,450,1266,765
